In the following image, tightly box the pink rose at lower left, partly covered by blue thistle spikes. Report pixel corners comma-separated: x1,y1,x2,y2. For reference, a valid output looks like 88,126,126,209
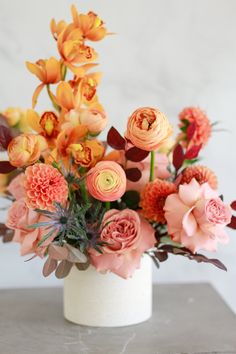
6,198,54,257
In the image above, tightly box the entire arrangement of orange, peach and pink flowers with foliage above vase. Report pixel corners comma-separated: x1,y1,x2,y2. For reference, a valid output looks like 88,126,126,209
0,6,236,278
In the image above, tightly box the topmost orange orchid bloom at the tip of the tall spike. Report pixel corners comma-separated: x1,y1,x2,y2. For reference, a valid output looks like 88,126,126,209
71,5,107,41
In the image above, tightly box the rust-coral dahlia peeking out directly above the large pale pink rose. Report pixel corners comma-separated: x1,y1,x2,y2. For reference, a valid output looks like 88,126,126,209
179,166,218,189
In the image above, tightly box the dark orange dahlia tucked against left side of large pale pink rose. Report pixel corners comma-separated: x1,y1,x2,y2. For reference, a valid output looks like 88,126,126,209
139,178,176,224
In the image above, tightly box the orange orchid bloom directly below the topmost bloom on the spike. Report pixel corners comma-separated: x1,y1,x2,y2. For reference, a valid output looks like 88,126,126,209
57,23,97,65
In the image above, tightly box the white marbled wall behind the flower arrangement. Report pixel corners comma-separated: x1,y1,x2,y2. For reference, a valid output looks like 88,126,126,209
0,0,236,311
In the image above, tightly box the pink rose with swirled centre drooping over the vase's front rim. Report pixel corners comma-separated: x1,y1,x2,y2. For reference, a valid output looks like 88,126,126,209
89,209,156,279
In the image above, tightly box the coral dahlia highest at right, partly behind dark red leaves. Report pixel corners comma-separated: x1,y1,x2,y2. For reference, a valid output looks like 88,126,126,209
179,107,211,146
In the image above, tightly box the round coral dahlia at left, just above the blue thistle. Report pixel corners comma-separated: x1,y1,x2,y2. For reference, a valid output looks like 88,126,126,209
25,163,68,211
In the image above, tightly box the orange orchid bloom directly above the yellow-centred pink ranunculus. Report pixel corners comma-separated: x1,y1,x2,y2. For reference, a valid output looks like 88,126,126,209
68,140,105,167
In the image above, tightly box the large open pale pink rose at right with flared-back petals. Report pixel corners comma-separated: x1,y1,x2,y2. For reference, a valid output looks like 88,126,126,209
164,178,232,253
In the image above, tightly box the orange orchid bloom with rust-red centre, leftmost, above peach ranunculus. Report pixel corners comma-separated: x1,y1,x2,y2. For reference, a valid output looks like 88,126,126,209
27,109,60,145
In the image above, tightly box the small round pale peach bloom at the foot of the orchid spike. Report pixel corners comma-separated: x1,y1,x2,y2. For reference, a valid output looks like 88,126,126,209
80,108,107,135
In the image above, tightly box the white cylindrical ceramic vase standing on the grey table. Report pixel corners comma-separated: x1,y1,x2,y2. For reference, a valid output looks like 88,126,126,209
64,255,152,327
